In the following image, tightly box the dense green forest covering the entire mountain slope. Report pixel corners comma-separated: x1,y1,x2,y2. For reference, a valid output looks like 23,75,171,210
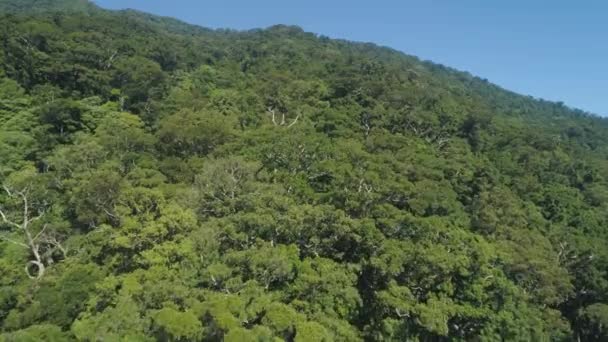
0,0,608,342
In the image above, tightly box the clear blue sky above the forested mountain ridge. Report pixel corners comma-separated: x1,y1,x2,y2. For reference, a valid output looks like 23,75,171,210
95,0,608,116
